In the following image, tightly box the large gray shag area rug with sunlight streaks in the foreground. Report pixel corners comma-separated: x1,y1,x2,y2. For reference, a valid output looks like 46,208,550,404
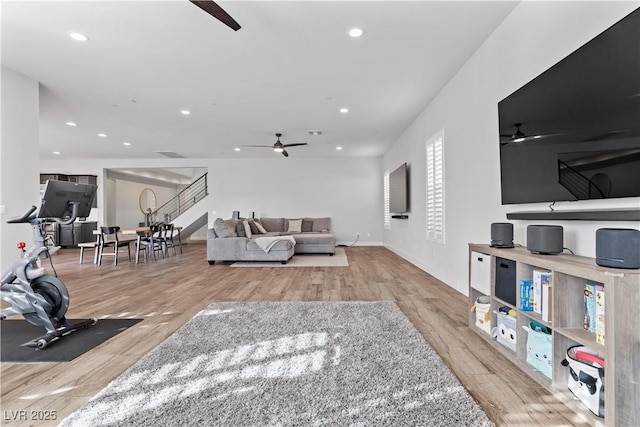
61,302,493,427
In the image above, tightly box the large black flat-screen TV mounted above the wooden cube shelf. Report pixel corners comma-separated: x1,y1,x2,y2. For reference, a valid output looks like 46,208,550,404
498,8,640,204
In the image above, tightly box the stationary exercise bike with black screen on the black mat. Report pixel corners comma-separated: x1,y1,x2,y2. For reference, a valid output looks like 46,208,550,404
0,181,97,349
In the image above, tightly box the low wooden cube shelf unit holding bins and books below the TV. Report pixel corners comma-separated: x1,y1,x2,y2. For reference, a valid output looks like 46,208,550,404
469,243,640,426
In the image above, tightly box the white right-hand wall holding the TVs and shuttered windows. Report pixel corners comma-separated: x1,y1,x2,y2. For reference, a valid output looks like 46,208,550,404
383,2,640,294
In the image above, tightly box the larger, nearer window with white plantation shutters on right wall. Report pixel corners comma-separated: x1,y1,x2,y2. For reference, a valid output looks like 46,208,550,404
425,129,444,243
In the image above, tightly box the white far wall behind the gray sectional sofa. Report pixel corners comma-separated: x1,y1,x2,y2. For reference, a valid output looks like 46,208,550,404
41,157,383,245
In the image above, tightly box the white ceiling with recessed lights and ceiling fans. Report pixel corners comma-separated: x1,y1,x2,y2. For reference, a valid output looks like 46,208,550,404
1,0,516,159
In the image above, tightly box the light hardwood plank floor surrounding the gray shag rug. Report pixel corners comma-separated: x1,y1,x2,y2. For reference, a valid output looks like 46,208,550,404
0,244,593,427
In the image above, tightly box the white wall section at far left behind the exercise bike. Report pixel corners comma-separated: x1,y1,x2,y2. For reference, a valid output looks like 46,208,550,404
0,67,40,274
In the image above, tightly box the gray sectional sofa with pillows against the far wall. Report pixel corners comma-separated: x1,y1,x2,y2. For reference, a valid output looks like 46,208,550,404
207,217,336,264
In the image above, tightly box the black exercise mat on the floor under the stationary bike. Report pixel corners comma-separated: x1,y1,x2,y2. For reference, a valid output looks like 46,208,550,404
0,319,142,362
